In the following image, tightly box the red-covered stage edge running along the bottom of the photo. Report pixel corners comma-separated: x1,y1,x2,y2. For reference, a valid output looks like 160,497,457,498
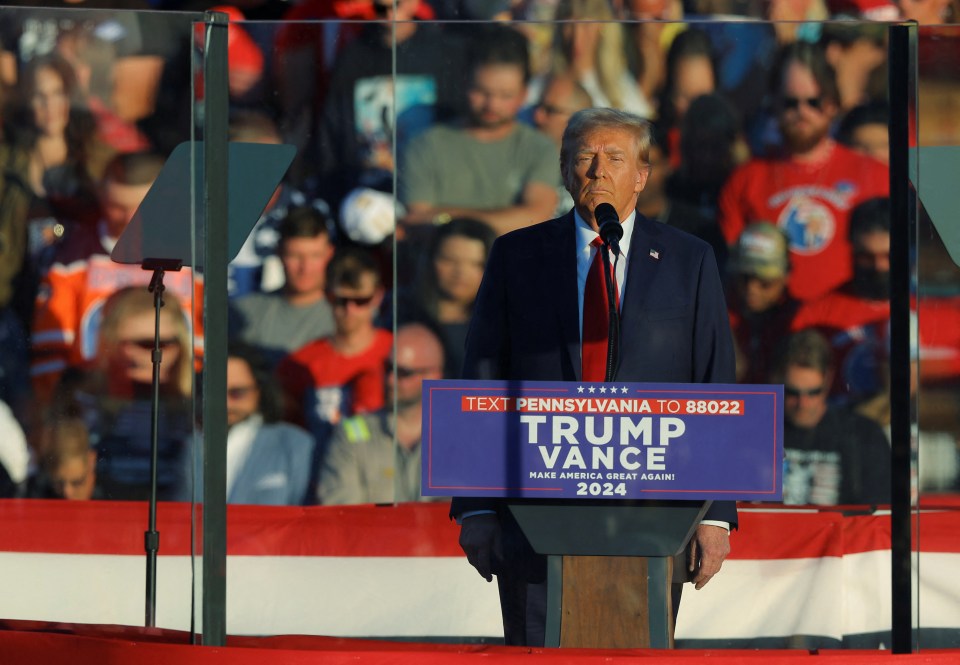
0,621,960,665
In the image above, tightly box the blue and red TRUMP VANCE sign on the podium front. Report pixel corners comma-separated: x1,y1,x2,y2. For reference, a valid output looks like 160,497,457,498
421,380,783,501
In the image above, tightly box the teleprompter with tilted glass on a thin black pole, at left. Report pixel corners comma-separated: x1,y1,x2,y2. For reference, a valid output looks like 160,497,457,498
110,141,296,627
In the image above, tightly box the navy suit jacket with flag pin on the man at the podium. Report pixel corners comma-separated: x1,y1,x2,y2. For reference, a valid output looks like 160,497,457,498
450,211,737,526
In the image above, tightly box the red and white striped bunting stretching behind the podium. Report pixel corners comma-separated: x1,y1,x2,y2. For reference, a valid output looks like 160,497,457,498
0,497,960,652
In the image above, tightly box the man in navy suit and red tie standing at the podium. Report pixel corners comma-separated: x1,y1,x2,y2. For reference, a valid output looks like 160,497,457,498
451,109,737,646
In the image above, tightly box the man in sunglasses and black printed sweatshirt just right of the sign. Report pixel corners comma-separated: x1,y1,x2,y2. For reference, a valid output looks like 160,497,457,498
772,329,890,506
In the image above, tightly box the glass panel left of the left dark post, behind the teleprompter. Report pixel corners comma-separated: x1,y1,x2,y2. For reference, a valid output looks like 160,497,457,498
0,0,201,630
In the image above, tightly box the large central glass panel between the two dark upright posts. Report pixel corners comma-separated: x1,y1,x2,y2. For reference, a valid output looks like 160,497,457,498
201,9,924,648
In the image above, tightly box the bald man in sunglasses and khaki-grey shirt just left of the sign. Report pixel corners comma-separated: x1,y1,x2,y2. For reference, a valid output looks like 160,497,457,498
317,323,444,505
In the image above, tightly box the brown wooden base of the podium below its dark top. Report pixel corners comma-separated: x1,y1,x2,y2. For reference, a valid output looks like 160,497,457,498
546,556,673,649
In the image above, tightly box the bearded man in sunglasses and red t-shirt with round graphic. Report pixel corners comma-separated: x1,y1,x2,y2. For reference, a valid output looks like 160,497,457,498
719,42,889,301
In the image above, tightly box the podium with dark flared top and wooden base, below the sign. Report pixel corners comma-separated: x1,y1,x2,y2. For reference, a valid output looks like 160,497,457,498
507,501,710,649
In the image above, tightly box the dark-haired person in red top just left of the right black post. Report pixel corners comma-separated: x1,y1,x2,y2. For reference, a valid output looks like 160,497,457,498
793,197,890,402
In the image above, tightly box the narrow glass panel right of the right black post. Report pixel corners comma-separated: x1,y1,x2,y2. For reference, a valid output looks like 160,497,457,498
915,18,960,648
